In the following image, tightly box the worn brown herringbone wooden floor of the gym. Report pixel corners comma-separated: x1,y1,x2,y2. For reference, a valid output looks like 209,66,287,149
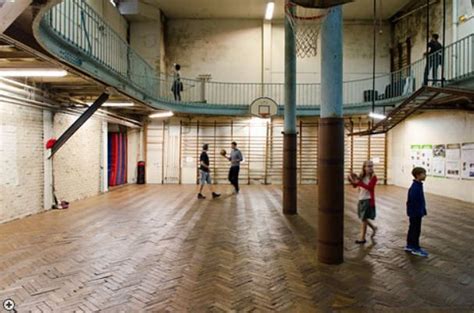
0,185,474,312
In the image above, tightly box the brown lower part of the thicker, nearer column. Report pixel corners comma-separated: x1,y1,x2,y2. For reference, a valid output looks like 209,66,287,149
317,117,344,264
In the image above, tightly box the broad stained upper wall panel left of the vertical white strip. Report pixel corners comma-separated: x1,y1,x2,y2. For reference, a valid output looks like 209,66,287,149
166,19,262,82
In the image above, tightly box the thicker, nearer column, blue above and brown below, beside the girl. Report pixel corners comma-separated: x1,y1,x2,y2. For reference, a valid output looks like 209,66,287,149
318,6,344,264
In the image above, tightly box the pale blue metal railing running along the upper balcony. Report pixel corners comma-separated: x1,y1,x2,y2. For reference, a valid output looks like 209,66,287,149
42,0,474,107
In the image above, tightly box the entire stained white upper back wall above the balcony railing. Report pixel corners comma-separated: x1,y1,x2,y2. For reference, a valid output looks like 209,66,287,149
166,19,391,87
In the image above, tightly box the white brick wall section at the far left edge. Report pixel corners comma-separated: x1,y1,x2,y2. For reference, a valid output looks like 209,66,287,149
0,102,44,222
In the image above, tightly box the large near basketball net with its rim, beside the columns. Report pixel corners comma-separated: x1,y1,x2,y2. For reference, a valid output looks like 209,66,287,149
285,2,327,58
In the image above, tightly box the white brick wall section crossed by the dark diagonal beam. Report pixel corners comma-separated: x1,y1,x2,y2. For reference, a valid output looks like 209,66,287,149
53,113,101,202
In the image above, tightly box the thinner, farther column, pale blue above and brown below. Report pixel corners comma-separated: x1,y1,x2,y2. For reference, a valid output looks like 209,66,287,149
283,0,297,214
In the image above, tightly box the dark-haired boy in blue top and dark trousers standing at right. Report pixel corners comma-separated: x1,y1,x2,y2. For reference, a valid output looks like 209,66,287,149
405,167,428,257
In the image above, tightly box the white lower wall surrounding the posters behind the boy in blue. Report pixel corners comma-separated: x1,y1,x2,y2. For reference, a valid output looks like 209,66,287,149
388,111,474,202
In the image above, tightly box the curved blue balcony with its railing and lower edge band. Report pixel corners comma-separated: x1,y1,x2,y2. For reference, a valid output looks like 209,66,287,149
34,0,474,116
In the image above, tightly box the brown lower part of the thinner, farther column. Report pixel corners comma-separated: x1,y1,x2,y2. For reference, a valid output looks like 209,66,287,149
283,133,298,214
